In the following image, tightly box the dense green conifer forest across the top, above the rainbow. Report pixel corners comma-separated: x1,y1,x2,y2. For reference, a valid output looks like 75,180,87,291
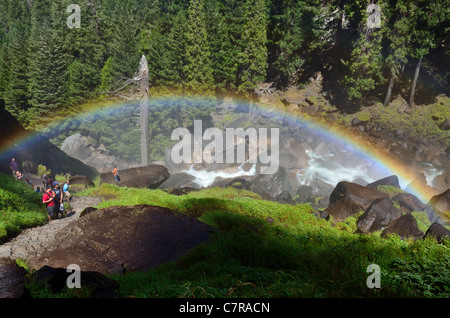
0,0,450,124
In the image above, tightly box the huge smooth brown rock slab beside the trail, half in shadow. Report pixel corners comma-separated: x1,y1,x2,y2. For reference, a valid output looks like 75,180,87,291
27,205,213,273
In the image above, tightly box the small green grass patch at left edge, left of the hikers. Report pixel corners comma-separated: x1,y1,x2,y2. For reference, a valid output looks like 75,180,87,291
0,173,47,243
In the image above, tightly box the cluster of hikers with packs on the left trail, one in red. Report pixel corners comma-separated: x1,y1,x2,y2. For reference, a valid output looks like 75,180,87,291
10,158,71,221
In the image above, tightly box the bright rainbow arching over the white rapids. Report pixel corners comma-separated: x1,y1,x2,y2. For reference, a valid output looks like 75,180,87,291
0,95,442,206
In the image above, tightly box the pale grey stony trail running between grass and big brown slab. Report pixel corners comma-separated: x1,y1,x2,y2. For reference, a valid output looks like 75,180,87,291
0,197,101,261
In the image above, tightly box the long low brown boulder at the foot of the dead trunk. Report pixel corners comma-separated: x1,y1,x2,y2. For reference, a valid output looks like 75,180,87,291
100,165,170,189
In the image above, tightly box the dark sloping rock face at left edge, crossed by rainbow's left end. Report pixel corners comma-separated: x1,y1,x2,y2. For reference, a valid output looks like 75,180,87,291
0,99,98,180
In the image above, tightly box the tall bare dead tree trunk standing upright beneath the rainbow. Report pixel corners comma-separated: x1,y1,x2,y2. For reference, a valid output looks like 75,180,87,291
139,55,150,166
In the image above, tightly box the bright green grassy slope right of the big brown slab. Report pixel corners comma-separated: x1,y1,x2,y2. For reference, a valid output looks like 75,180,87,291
22,184,450,298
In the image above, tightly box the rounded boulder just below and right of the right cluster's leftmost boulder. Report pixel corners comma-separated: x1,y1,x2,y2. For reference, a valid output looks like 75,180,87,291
356,198,402,233
